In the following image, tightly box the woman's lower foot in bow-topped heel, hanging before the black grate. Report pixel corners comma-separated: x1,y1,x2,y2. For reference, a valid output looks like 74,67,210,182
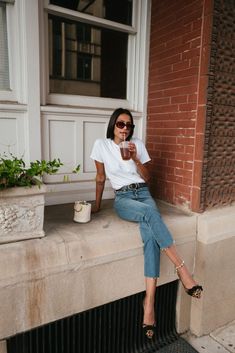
142,297,156,339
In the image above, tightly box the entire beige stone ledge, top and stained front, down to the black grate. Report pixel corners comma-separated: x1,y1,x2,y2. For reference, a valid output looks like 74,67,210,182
0,200,197,339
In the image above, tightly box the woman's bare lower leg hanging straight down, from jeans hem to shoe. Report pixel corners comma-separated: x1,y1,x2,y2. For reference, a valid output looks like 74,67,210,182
143,277,157,325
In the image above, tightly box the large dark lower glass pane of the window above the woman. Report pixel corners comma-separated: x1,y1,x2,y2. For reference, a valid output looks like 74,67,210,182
49,16,128,99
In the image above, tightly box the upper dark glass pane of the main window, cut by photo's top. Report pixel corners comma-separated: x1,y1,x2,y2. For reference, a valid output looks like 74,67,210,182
51,0,132,25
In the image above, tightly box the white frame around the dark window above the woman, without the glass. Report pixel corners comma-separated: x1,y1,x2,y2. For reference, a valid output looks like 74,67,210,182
40,0,150,111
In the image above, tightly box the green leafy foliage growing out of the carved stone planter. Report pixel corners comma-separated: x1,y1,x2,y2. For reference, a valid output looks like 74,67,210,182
0,154,64,190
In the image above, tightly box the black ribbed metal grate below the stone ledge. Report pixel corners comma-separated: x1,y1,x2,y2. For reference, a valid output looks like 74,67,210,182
7,281,178,353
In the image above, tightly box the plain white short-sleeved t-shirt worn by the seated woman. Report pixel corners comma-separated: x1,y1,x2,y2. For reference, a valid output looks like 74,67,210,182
91,138,150,190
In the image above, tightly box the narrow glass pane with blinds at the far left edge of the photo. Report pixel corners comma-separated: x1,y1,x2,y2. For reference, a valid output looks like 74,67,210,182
0,2,10,90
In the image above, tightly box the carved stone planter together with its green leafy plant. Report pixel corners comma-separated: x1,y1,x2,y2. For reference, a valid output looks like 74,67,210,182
0,154,76,243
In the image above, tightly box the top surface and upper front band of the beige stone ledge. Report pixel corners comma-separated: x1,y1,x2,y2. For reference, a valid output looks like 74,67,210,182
0,200,196,284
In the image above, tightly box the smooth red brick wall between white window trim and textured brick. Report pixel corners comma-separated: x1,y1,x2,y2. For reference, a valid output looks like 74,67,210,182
147,0,211,210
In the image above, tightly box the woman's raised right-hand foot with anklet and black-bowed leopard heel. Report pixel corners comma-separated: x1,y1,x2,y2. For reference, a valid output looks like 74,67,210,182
175,261,203,299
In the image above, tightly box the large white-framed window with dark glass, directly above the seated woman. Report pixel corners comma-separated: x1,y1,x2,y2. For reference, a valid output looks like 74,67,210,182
41,0,150,109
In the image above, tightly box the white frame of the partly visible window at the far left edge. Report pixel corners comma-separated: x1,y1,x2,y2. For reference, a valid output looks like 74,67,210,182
0,1,23,102
